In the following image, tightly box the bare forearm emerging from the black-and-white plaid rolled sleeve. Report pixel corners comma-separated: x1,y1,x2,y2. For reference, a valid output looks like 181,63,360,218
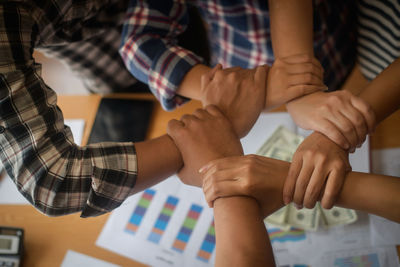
133,135,183,193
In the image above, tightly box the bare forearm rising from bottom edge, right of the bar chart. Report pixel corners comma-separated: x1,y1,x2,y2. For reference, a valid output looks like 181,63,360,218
214,197,275,267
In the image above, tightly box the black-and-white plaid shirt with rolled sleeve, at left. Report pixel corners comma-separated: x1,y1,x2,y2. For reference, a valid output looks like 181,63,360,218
0,0,142,217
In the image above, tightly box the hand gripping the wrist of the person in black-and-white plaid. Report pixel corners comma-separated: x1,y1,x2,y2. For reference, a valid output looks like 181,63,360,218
167,106,243,187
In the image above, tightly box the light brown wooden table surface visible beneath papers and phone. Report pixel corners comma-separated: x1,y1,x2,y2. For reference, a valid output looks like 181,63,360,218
0,91,400,267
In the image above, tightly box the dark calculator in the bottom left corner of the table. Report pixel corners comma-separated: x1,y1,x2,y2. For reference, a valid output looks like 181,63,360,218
0,226,24,267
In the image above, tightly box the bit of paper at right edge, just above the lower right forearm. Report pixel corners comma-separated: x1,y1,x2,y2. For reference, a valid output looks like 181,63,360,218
372,147,400,177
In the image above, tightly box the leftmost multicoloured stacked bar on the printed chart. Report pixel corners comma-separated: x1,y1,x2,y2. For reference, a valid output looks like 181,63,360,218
125,189,156,234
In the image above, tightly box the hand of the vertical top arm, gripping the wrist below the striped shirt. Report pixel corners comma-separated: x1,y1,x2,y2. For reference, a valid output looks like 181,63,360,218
286,91,375,151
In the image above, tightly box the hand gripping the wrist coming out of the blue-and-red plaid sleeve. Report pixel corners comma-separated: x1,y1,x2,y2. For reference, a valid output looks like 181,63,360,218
201,64,267,137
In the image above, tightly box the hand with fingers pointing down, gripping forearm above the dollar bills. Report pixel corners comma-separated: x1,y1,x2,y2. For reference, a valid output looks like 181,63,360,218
283,132,351,209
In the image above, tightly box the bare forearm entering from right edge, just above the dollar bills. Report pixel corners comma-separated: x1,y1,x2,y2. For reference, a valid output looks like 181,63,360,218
336,172,400,223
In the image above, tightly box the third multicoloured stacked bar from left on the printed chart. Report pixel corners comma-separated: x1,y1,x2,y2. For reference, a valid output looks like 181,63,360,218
172,204,203,253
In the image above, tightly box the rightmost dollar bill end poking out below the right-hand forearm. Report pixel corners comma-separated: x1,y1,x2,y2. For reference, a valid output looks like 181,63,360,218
317,203,357,227
